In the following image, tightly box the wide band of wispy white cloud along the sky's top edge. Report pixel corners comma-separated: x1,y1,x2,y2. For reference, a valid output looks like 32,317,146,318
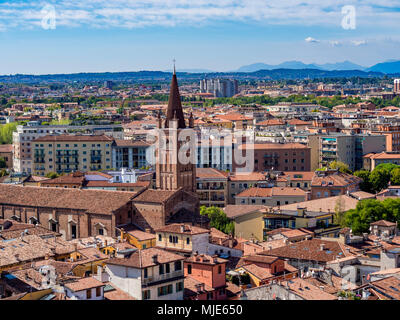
0,0,400,28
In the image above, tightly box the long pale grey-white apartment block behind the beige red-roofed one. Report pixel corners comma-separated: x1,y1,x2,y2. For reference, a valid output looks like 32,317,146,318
13,123,124,173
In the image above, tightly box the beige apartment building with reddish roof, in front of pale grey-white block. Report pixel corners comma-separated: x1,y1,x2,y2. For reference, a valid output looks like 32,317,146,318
32,135,114,176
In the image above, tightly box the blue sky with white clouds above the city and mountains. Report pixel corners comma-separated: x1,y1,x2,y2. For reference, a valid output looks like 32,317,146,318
0,0,400,74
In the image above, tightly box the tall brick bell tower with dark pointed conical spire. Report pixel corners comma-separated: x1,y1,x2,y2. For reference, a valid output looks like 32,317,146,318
156,65,196,192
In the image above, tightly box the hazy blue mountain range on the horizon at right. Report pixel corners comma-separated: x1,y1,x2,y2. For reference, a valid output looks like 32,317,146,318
235,61,400,74
